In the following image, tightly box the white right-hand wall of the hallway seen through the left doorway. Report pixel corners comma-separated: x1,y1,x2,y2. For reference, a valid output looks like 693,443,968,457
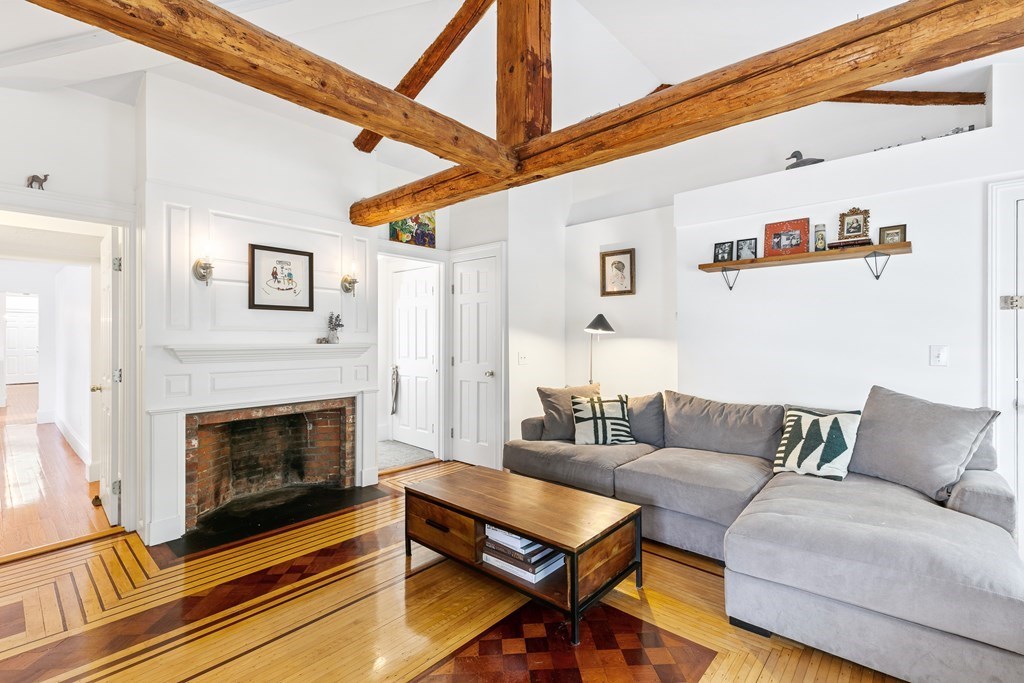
53,265,93,465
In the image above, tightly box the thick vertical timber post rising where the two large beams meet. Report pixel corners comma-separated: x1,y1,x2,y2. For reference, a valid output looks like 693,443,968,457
498,0,551,146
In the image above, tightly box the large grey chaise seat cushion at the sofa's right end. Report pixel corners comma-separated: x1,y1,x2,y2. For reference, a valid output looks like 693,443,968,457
725,473,1024,654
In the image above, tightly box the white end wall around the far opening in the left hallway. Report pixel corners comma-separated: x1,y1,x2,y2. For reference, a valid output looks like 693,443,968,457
0,260,62,423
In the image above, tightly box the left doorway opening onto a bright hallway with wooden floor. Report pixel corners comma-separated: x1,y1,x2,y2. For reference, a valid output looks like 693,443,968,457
0,212,120,556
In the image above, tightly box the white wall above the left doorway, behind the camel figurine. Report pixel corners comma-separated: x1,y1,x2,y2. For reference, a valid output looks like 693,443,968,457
0,88,135,204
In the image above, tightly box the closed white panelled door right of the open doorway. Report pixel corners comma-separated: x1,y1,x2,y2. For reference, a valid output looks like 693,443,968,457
452,250,504,469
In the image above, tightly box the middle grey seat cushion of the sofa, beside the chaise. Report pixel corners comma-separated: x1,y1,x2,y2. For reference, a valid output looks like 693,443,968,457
615,449,771,526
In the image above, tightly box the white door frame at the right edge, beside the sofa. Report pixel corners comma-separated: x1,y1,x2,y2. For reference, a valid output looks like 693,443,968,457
986,177,1024,544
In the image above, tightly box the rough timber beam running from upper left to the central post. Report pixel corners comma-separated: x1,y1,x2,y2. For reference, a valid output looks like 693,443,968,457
29,0,517,177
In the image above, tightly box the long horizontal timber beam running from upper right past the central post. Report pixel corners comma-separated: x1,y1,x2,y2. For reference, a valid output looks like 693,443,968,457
349,0,1024,226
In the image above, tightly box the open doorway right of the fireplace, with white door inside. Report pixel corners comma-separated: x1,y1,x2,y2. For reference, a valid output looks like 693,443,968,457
377,254,443,472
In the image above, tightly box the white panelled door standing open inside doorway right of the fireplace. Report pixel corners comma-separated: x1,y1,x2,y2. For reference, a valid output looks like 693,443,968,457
391,266,439,455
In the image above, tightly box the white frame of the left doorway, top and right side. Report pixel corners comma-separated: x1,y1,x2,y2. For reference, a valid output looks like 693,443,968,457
0,185,139,531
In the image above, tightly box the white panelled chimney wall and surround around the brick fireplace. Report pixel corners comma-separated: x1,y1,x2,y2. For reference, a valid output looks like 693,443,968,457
139,75,385,544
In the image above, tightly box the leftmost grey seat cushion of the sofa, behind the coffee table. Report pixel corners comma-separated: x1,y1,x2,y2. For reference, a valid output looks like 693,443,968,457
503,440,654,496
